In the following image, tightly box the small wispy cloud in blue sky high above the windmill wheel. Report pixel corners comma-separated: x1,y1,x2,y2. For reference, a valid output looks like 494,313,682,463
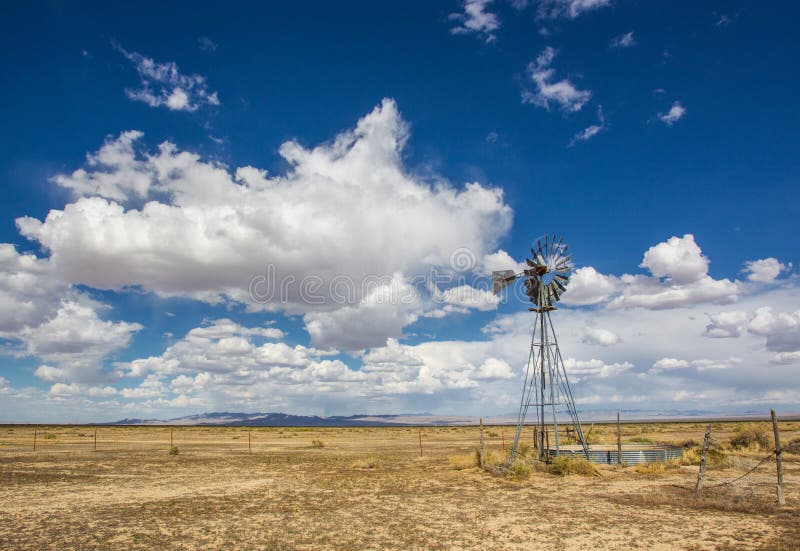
522,46,592,113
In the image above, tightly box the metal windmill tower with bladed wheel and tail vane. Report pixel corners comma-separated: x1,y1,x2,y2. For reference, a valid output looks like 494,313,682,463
492,235,589,461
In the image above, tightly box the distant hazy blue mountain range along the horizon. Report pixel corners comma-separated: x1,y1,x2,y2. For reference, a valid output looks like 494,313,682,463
93,410,798,427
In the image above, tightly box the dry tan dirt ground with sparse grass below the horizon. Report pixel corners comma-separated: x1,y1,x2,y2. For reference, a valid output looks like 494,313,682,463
0,422,800,549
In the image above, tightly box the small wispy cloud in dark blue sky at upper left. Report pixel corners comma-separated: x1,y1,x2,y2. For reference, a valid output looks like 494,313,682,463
116,46,220,112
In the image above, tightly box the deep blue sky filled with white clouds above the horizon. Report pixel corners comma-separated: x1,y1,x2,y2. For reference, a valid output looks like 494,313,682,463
0,0,800,421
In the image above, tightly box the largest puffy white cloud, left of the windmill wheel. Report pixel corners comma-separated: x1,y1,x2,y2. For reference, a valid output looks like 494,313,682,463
17,100,512,352
